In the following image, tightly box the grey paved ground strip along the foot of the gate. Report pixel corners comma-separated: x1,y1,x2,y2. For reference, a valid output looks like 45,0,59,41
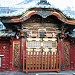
0,71,75,75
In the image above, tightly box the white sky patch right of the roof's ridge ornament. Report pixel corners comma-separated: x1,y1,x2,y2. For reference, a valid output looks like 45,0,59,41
47,0,75,9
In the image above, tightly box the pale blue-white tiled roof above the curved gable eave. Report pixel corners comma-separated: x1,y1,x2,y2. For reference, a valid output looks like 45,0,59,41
0,0,75,19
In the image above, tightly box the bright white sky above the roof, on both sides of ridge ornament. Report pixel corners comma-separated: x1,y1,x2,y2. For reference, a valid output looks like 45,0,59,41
0,0,75,9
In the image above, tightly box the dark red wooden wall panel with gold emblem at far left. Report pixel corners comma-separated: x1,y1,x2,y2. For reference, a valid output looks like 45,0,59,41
0,43,10,70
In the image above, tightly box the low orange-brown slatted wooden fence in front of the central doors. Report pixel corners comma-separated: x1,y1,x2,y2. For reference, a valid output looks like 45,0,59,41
23,52,61,73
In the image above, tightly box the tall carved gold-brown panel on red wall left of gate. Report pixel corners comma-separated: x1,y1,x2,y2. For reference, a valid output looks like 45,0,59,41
13,41,20,68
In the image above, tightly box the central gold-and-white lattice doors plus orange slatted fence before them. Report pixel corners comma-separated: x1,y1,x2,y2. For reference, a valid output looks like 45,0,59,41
23,37,61,72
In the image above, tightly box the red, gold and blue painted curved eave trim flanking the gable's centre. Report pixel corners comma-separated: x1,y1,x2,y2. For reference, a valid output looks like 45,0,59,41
11,8,75,25
